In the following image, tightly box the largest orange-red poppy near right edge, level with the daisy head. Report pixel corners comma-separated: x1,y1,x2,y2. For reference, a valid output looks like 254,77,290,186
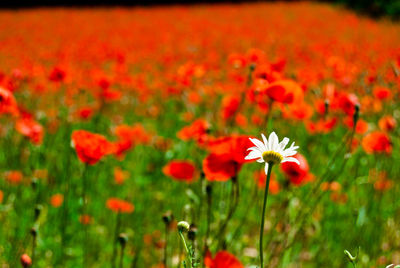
361,131,392,154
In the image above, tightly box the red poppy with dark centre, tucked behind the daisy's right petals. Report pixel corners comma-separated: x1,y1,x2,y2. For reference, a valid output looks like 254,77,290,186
281,153,310,185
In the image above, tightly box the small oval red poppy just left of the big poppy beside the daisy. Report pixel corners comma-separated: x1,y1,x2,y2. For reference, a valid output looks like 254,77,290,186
163,160,196,182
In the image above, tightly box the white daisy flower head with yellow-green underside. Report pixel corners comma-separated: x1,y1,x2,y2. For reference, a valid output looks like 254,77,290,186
244,132,300,174
